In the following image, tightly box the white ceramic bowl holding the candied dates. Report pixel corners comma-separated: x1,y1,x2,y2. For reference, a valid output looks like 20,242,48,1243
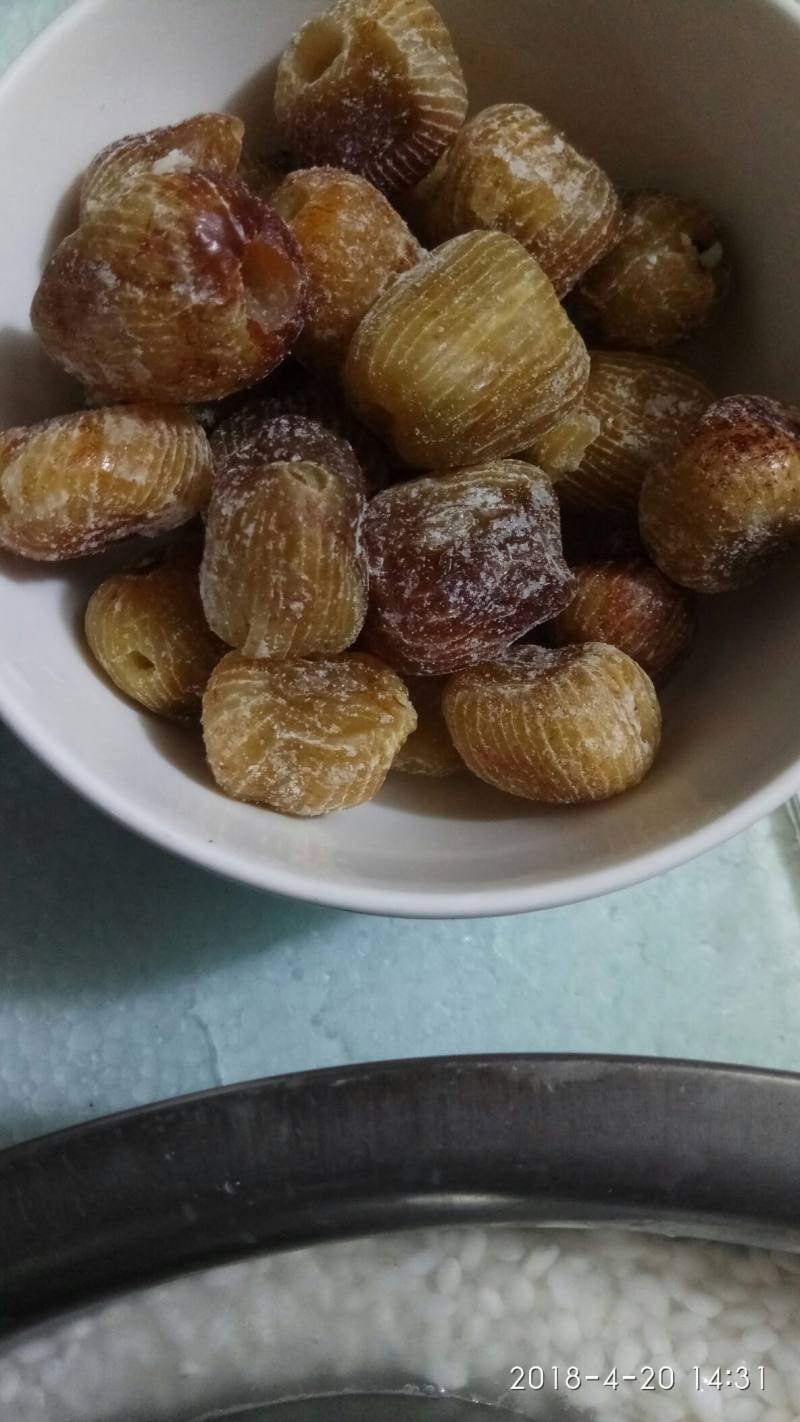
0,0,800,916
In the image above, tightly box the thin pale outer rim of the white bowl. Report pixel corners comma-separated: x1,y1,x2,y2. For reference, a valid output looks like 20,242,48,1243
0,0,800,919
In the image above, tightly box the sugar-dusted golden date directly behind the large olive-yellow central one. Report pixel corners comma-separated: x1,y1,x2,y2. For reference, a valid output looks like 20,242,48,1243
413,104,622,296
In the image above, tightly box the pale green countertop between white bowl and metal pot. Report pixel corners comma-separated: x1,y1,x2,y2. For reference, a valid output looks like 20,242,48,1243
0,0,800,1145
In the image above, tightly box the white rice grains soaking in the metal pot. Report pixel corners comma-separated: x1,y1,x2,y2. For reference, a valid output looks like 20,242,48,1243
0,1228,800,1422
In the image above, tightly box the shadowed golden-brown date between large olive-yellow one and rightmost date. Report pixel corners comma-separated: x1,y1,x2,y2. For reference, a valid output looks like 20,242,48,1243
531,351,713,523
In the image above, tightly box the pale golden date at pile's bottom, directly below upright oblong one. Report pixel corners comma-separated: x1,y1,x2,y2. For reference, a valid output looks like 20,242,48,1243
203,653,416,816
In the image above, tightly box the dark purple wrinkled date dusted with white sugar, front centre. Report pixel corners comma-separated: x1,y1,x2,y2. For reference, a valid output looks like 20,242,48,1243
364,459,573,675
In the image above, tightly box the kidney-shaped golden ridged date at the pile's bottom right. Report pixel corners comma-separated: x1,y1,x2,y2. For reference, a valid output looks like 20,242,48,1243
442,643,661,805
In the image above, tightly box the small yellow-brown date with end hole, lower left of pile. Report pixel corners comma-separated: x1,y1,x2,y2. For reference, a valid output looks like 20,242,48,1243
85,552,227,721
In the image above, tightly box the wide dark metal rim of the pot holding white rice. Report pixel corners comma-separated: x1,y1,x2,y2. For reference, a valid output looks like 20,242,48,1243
0,1054,800,1332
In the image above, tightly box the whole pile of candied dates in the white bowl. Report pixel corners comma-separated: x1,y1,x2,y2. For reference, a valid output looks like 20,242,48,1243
0,0,800,815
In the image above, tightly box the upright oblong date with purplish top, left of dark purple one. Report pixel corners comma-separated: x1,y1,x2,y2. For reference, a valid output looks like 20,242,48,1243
200,415,367,658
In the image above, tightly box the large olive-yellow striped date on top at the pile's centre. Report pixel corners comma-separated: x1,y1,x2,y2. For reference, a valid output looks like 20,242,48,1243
344,232,588,469
